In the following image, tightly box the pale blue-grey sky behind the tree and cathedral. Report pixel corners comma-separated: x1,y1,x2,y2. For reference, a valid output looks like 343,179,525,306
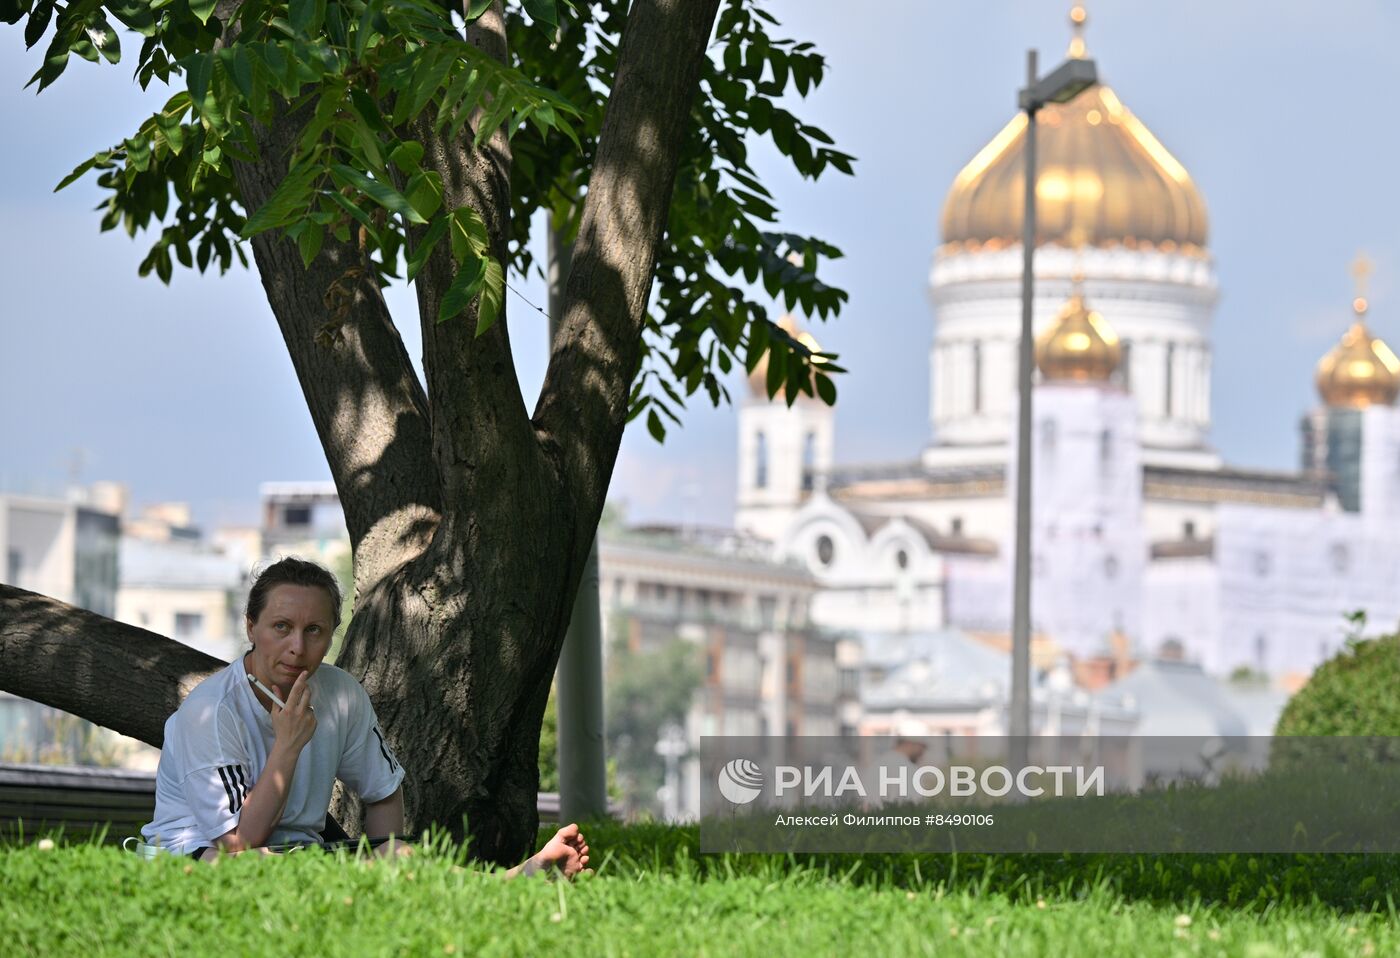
0,0,1400,525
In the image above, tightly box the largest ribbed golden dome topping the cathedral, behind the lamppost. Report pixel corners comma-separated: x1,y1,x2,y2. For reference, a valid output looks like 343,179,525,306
942,7,1207,255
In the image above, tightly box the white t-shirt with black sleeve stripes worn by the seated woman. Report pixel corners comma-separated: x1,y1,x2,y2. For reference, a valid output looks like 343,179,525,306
141,655,403,854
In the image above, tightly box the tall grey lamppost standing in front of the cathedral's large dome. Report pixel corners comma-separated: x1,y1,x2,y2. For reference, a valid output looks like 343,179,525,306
1009,50,1099,769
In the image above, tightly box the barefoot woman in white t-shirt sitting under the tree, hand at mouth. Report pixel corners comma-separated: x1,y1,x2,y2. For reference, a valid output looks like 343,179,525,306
141,557,588,878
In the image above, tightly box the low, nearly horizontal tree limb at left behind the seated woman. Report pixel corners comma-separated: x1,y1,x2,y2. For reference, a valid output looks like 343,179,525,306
0,585,227,748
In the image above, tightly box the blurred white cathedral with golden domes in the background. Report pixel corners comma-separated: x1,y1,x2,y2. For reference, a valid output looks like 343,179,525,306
735,10,1400,678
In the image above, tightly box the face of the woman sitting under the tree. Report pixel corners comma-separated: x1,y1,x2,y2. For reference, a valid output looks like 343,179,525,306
246,585,336,697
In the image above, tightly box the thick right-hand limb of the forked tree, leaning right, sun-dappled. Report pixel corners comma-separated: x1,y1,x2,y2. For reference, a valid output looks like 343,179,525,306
535,0,720,537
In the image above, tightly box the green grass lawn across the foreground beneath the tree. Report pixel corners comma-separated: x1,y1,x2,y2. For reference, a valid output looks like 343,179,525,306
0,825,1400,958
